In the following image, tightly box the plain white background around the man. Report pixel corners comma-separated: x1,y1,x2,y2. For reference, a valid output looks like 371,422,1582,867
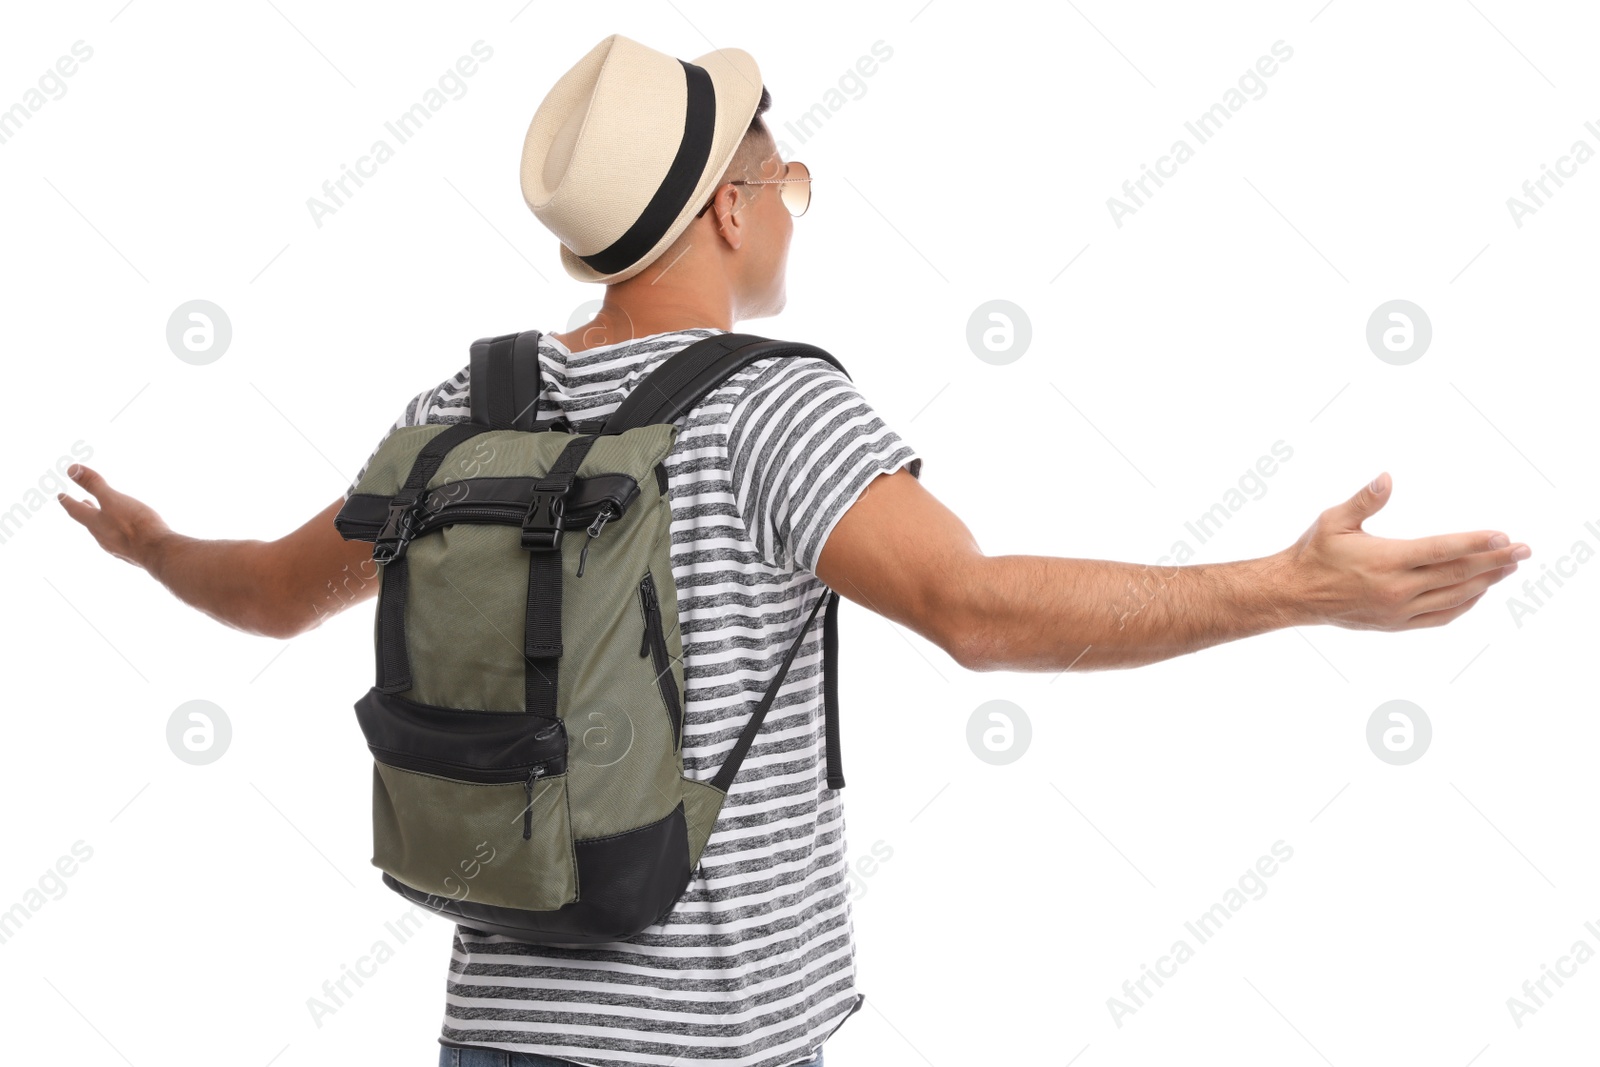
0,0,1600,1067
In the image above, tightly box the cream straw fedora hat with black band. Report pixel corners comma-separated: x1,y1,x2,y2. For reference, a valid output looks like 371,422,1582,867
522,34,762,282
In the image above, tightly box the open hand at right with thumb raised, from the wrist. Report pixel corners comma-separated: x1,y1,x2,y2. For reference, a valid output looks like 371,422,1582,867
1274,472,1531,630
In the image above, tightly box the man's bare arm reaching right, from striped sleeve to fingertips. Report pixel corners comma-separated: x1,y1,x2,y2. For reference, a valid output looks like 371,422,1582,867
816,470,1526,670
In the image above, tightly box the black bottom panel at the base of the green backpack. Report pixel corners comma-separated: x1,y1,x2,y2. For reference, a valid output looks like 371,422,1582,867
384,800,690,945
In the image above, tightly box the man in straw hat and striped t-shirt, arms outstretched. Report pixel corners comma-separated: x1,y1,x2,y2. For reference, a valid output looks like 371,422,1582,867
53,35,1528,1067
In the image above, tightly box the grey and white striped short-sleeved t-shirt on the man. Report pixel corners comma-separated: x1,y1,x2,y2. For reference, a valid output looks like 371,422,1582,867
347,328,922,1067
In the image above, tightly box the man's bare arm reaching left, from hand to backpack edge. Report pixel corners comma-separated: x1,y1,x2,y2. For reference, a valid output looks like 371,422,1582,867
59,464,378,638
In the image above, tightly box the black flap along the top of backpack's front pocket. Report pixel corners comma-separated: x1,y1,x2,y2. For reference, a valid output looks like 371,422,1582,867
355,688,566,781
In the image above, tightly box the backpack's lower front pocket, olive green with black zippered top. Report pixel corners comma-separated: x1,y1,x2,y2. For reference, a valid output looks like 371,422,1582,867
355,689,578,912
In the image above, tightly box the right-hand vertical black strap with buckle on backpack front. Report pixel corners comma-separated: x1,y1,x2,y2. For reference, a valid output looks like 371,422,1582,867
522,435,598,718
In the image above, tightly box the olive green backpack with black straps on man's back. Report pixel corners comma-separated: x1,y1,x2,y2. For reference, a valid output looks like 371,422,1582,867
334,331,845,944
